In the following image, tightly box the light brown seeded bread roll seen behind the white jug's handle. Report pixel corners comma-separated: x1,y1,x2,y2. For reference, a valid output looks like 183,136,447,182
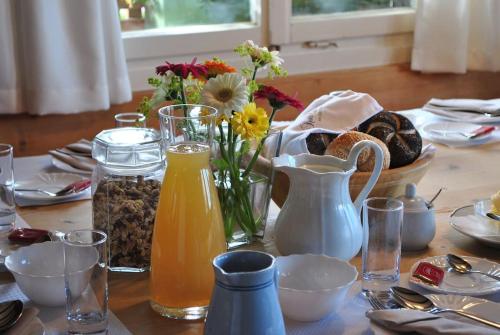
325,131,391,172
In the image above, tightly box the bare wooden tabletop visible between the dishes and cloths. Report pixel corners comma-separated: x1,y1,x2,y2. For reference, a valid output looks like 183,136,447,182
10,143,500,334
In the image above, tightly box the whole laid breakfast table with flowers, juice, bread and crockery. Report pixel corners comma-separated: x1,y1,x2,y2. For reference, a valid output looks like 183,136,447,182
0,41,500,335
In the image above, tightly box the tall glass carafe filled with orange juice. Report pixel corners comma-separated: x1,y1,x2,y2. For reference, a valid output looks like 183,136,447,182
150,105,226,319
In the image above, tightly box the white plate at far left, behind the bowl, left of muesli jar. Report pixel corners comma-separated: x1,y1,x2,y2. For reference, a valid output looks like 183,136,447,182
16,173,86,201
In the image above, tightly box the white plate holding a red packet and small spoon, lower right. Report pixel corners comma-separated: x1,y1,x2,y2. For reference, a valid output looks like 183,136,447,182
409,255,500,296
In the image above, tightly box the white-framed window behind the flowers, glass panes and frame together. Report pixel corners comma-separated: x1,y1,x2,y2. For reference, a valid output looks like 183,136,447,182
121,0,416,90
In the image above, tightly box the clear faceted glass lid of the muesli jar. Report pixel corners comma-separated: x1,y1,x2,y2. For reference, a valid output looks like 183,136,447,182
92,127,164,168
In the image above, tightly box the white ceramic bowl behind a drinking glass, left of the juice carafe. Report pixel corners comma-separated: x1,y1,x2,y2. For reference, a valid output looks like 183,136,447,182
5,242,98,306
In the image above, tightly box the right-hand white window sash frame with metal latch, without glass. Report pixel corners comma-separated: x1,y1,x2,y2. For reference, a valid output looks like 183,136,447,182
269,0,416,74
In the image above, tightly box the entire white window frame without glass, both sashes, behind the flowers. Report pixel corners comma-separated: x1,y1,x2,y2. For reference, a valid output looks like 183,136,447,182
122,0,415,91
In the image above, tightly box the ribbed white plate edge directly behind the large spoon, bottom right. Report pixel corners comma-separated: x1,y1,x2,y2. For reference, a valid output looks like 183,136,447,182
426,294,500,323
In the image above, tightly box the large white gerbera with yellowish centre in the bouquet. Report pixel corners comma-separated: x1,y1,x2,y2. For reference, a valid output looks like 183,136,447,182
201,73,248,118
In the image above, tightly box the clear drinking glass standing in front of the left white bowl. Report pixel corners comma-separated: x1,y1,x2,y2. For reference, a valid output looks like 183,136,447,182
63,230,108,334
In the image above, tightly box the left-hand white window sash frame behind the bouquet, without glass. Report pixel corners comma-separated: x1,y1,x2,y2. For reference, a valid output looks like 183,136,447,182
122,0,264,91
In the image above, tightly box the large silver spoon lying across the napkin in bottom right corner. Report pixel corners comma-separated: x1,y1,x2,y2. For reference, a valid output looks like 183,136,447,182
391,286,500,329
